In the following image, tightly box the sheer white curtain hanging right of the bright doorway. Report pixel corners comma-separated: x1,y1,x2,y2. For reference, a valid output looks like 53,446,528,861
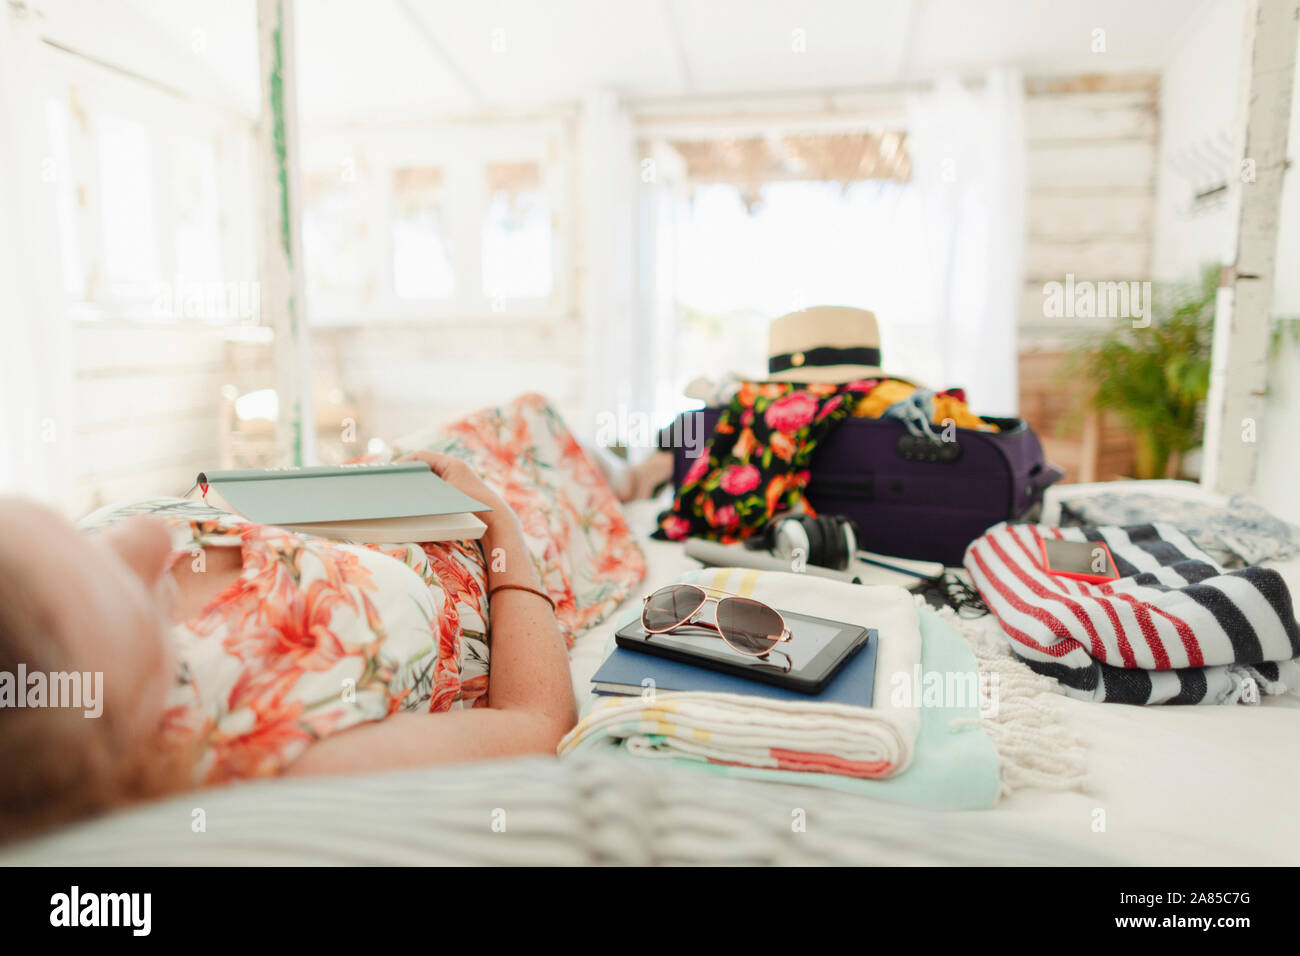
907,70,1026,415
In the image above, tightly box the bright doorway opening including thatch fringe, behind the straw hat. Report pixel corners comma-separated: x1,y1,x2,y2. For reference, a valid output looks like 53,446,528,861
641,127,937,414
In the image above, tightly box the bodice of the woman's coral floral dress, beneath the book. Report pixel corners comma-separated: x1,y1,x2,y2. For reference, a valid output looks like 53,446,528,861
77,498,489,783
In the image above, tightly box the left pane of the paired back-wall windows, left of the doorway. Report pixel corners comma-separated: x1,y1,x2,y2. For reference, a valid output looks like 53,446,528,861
391,166,456,299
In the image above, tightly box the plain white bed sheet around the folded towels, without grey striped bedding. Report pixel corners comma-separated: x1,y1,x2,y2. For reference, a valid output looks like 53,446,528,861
585,501,1300,865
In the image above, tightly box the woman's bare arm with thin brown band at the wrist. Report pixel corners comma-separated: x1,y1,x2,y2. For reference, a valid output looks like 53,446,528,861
285,451,577,774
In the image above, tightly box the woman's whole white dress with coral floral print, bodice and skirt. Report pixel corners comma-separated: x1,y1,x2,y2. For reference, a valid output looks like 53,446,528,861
82,395,645,783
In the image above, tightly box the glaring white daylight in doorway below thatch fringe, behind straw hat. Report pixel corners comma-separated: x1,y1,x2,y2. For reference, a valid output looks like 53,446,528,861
675,181,939,386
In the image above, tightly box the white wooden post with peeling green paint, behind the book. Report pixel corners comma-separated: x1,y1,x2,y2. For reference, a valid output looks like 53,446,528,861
257,0,316,464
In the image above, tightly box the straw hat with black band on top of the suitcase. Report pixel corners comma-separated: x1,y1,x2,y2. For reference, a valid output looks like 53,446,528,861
767,306,884,385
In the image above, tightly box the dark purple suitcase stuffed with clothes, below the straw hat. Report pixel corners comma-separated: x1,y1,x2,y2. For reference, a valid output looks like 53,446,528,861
670,408,1063,567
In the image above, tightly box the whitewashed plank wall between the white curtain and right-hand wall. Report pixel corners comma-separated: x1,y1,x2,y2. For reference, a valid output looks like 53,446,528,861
1019,74,1160,481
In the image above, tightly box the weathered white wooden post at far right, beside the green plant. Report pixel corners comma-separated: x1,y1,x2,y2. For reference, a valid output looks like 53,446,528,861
1203,0,1300,494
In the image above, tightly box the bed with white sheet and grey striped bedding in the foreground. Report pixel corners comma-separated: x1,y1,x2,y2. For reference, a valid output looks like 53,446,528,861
0,489,1300,865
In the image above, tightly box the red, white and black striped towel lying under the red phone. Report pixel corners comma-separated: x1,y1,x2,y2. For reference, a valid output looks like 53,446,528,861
965,524,1300,704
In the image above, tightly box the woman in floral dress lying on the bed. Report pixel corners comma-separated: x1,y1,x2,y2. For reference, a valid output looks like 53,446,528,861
0,395,645,839
